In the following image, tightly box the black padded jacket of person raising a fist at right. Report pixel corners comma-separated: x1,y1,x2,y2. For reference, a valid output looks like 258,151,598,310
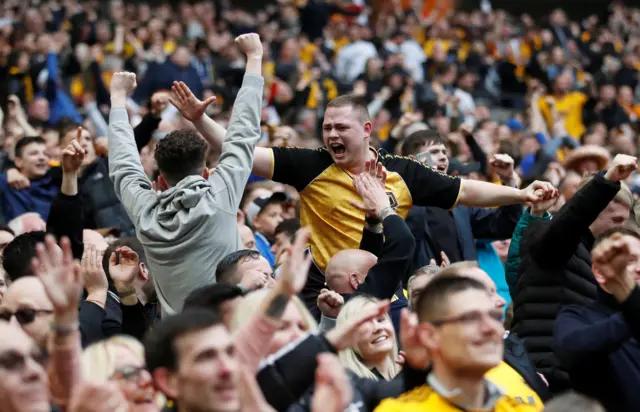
511,173,620,393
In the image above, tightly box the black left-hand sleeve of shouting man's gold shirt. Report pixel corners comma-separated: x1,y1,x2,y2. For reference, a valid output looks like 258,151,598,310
271,147,333,192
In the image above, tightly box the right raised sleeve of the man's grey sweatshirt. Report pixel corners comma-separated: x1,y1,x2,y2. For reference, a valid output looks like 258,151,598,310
209,73,264,214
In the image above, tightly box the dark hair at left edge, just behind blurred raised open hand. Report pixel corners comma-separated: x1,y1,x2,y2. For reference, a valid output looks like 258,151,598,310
2,231,47,282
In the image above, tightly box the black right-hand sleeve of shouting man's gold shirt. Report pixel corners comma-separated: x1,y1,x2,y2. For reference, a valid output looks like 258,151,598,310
379,151,462,209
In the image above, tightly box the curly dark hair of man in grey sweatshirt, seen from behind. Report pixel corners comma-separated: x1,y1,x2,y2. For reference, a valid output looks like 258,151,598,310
155,129,208,185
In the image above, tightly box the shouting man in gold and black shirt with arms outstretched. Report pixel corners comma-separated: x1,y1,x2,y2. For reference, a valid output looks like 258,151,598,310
172,83,557,314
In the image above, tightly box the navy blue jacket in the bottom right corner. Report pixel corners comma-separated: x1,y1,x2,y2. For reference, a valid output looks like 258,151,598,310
554,287,640,412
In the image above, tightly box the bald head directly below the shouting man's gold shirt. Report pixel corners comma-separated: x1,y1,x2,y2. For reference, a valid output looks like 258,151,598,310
325,249,378,294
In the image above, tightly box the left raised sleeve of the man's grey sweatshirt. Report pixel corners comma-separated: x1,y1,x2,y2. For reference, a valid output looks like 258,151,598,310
107,107,157,227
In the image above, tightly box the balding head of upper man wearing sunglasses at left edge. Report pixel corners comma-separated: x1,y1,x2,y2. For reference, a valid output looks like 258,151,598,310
0,276,53,348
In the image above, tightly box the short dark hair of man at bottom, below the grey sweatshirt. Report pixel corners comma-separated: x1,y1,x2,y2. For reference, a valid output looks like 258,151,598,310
144,309,222,372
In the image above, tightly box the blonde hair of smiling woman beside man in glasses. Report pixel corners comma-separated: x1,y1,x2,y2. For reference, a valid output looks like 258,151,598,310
336,296,401,380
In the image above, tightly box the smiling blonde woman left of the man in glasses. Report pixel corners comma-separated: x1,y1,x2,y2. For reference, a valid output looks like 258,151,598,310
336,296,401,381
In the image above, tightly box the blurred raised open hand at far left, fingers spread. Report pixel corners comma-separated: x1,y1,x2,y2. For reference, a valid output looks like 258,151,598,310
32,235,83,314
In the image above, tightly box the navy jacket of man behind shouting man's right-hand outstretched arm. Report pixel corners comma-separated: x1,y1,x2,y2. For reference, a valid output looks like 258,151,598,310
406,205,523,273
